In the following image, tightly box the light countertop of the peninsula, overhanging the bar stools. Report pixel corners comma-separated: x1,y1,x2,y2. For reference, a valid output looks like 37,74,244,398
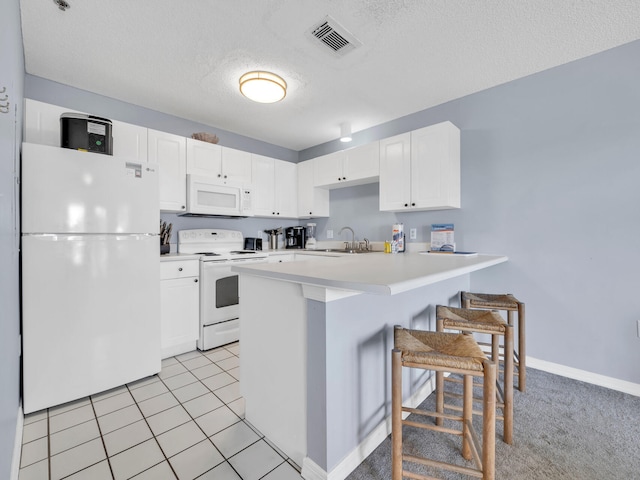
232,253,508,295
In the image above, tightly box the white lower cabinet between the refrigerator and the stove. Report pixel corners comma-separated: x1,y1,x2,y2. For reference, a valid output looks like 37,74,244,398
160,257,200,358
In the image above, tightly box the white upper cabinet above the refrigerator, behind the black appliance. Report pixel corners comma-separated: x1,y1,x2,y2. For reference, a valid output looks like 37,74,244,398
23,98,147,162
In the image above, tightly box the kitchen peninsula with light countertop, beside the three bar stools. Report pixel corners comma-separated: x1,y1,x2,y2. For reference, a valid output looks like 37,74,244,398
233,253,507,480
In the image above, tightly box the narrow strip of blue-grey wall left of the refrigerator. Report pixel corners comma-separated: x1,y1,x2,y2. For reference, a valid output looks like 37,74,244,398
0,0,24,479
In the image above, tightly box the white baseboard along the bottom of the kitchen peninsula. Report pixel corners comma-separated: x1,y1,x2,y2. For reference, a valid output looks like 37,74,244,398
302,375,435,480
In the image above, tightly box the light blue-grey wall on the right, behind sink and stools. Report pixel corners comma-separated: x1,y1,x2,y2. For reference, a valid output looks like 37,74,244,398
308,41,640,384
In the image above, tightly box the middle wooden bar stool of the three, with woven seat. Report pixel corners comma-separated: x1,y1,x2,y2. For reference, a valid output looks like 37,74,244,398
436,305,513,444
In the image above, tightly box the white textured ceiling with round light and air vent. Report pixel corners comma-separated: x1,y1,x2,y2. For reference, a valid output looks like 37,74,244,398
20,0,640,150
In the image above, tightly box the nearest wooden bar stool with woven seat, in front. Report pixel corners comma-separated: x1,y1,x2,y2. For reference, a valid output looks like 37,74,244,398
391,326,497,480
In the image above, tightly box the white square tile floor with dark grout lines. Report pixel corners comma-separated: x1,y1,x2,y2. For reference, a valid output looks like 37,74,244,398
19,343,302,480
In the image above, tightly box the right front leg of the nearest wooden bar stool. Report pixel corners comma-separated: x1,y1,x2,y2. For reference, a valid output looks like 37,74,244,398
482,360,497,480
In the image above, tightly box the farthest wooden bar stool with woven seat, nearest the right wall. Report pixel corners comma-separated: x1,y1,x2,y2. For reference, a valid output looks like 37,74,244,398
460,292,527,392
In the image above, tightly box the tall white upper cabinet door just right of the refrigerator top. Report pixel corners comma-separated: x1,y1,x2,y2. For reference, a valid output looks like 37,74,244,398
148,130,187,212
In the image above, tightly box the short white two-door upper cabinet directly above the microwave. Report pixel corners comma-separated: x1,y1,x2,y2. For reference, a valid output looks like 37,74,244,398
187,138,251,185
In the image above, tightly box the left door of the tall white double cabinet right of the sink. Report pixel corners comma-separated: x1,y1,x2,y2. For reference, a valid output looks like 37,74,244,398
380,133,411,211
